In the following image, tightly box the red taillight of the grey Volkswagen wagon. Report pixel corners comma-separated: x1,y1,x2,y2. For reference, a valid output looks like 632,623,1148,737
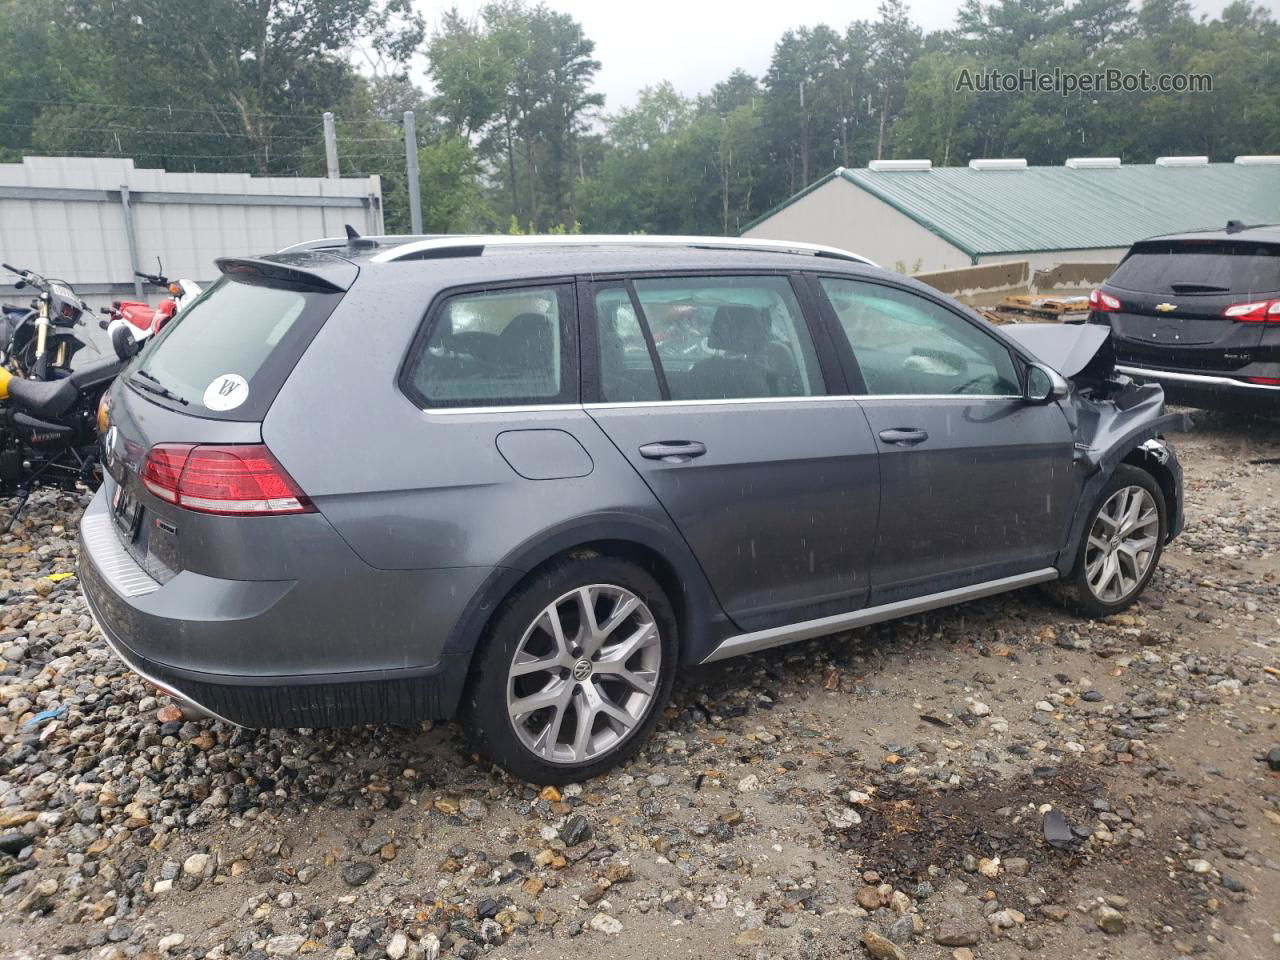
142,443,315,517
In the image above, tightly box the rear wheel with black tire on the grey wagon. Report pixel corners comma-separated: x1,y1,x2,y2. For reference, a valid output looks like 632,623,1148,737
460,556,678,783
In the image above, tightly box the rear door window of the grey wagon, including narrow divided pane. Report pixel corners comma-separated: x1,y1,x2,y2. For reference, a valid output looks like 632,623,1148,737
596,276,824,401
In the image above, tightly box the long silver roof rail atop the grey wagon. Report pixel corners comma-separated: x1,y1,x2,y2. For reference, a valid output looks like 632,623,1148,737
360,233,878,266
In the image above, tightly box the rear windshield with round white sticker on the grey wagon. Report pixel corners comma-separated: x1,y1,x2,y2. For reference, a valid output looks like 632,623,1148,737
125,276,342,420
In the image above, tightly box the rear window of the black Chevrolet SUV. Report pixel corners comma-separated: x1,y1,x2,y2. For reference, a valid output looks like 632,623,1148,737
1107,241,1280,296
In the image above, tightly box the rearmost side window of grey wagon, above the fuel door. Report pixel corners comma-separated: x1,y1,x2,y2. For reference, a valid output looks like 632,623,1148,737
404,284,577,407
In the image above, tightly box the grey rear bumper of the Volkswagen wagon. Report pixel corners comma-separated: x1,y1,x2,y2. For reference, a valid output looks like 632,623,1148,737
79,490,488,728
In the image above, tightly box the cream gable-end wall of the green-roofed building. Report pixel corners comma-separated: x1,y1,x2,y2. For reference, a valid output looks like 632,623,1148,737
742,177,972,273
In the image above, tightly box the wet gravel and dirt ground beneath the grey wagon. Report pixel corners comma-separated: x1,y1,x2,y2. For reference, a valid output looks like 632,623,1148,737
0,415,1280,960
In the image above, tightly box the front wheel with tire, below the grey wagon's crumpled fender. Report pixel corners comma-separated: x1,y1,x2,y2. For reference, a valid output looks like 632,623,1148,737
1061,463,1169,618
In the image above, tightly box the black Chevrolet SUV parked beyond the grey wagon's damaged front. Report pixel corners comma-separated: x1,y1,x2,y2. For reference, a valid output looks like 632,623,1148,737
1089,220,1280,410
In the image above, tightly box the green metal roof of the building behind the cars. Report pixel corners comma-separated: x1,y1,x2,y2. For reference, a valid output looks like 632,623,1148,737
753,164,1280,257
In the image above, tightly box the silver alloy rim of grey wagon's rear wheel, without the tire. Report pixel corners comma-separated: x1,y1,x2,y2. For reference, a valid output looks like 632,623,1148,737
507,584,662,764
